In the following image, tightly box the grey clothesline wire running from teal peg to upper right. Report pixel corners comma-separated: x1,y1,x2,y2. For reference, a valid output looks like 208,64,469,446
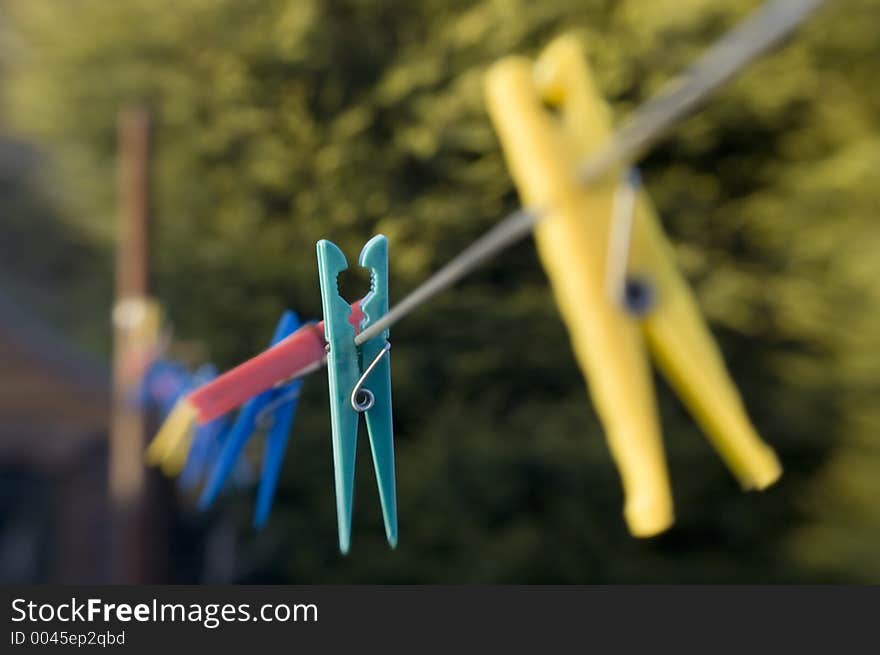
344,0,824,345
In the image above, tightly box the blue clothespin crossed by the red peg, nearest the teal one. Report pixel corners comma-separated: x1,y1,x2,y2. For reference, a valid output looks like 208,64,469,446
199,311,303,528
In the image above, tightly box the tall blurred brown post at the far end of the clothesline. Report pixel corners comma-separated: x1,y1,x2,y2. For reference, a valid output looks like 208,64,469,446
109,109,161,584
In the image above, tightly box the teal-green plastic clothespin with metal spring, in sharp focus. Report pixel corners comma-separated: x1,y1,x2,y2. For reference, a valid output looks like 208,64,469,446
318,234,397,553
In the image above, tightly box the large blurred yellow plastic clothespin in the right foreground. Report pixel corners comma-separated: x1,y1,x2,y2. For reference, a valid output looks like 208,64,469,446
486,36,781,536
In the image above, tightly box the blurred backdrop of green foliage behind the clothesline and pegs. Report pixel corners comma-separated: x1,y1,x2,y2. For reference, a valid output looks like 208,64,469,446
0,0,880,583
